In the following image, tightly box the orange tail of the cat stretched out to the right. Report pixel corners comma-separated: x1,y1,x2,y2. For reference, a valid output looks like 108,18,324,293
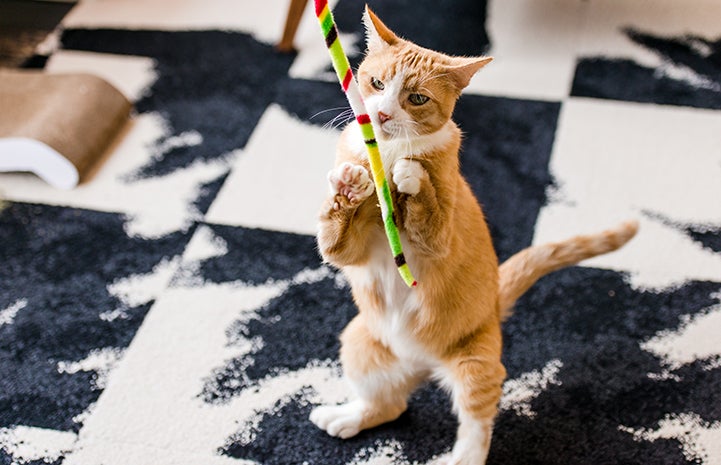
498,221,638,318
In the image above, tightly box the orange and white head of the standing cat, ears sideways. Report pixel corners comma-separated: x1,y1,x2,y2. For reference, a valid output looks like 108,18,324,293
358,7,492,139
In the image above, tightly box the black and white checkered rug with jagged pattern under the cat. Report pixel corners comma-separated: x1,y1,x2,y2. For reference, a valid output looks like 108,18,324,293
0,0,721,465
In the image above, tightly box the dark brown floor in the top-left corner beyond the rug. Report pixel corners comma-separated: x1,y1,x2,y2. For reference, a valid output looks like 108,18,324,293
0,0,75,68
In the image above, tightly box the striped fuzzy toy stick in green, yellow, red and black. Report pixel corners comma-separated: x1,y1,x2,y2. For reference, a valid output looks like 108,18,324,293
315,0,418,287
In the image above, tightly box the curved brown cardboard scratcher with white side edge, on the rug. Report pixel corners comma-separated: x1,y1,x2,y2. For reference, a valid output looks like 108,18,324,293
0,70,132,189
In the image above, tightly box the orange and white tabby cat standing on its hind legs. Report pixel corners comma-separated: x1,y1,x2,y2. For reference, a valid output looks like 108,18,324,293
310,9,637,465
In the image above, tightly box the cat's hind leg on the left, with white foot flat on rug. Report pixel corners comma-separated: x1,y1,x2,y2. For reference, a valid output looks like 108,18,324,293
310,315,425,439
